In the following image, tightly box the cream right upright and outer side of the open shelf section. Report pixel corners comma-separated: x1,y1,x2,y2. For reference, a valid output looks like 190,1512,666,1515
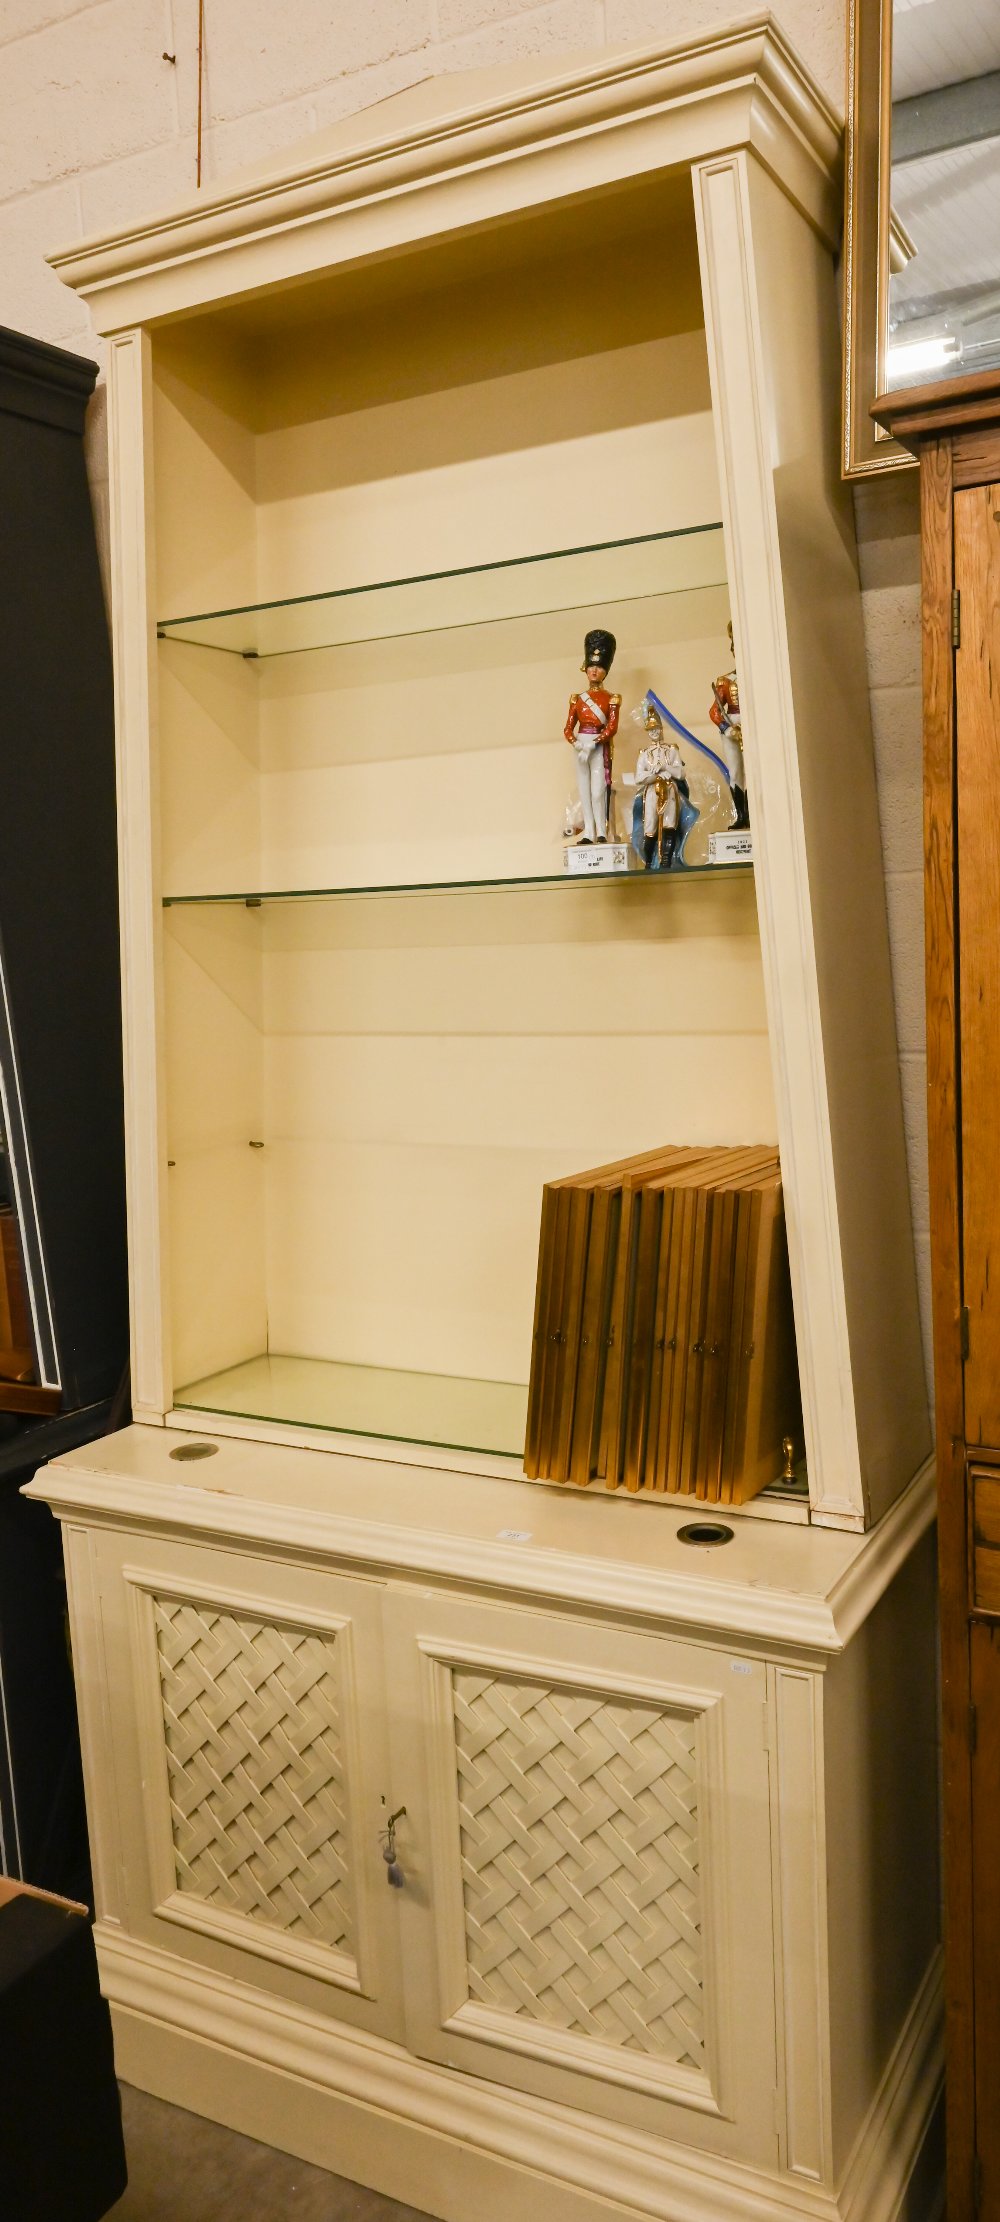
696,153,929,1527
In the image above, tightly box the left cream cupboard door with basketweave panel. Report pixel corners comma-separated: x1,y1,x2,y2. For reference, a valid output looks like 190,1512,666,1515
96,1535,400,2035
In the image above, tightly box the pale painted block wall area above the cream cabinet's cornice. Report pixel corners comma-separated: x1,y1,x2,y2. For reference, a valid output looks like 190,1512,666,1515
0,0,844,347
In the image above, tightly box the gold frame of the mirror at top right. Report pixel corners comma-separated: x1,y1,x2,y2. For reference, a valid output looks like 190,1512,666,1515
842,0,913,478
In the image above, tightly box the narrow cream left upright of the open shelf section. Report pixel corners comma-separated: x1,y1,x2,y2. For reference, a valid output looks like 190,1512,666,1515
109,331,171,1420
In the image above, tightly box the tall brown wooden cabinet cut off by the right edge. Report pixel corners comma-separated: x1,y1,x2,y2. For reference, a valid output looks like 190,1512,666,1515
878,391,1000,2222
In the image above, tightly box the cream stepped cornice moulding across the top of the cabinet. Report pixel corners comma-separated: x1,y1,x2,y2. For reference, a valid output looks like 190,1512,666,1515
49,13,840,331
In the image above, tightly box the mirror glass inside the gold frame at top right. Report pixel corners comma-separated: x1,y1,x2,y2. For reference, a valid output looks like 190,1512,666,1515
884,0,1000,387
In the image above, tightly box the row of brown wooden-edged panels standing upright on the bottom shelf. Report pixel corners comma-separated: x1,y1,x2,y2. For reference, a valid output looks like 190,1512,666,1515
524,1147,802,1504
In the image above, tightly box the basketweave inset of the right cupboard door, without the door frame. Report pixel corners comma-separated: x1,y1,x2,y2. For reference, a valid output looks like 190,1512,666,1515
451,1667,707,2071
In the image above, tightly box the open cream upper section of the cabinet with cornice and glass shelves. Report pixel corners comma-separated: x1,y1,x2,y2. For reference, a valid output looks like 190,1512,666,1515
58,20,927,1527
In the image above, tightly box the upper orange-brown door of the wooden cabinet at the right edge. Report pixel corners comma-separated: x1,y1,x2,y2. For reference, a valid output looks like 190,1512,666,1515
956,484,1000,1449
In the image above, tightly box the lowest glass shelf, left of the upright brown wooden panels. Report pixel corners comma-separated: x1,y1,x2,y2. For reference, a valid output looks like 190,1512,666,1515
173,1355,527,1458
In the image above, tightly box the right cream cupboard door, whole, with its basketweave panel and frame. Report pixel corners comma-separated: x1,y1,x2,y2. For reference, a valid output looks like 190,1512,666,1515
384,1591,776,2162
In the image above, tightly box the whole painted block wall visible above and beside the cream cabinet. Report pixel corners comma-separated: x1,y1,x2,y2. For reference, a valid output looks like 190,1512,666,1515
0,0,929,1395
